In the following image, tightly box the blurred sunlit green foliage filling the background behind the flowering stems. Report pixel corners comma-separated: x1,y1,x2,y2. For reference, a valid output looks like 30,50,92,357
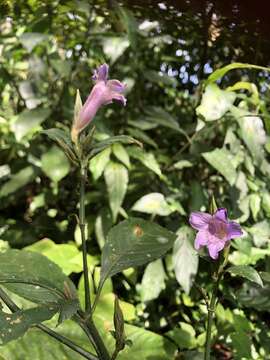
0,0,270,360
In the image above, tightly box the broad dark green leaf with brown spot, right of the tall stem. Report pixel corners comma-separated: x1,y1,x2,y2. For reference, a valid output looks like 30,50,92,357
100,218,175,284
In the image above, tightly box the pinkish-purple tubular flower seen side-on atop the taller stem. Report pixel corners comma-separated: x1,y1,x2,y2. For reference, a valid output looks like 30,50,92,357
72,64,127,139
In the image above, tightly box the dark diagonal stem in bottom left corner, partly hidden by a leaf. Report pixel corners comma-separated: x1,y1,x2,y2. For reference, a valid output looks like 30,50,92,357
0,288,99,360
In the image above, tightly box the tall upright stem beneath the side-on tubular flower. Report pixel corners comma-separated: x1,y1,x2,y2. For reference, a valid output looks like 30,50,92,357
79,165,91,313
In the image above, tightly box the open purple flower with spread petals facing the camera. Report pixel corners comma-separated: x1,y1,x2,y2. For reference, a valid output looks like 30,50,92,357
189,208,243,259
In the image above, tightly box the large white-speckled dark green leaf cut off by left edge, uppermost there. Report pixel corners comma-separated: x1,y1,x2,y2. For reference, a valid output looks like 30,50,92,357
0,249,77,304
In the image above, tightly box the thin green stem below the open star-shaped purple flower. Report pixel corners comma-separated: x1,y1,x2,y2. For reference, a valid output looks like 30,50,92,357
204,270,222,360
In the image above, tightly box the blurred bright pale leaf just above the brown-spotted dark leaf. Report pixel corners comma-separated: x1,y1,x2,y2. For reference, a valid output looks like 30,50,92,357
132,193,172,216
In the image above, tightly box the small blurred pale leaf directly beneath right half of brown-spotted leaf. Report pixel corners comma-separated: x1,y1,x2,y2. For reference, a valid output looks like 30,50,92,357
140,259,165,302
